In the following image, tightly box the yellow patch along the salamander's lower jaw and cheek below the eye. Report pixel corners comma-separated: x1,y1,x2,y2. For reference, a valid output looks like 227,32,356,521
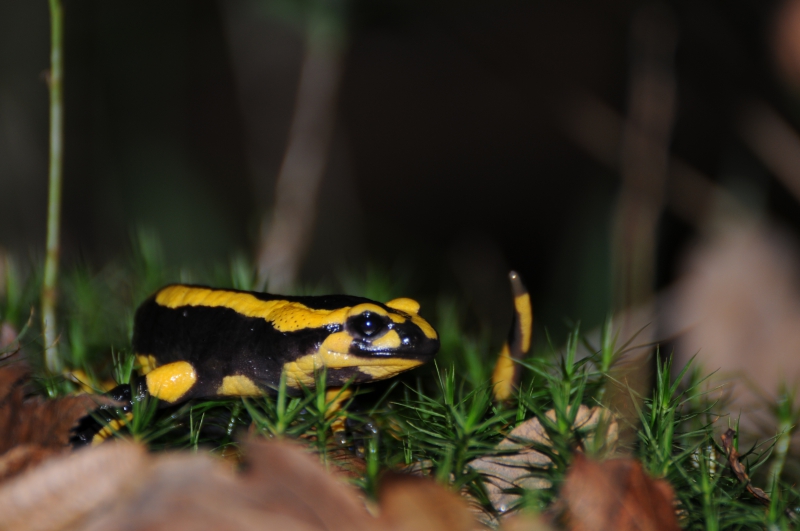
283,332,422,388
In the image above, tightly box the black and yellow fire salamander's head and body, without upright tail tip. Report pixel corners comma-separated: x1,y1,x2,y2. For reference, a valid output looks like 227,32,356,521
72,284,439,445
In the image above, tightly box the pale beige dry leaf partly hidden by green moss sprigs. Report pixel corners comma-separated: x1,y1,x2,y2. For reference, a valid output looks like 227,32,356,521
469,405,618,513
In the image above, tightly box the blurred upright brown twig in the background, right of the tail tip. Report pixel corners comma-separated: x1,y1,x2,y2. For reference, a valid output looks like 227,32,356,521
613,5,677,309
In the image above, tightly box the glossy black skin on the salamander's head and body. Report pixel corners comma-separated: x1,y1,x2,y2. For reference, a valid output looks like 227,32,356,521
133,290,439,400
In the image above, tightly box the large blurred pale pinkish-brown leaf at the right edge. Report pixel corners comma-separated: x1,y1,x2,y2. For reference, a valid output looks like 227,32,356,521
659,220,800,433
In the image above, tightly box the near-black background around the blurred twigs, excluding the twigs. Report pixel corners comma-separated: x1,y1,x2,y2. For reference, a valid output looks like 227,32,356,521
0,0,800,338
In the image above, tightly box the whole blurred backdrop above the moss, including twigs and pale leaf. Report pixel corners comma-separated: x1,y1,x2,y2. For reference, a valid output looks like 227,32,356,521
0,0,800,420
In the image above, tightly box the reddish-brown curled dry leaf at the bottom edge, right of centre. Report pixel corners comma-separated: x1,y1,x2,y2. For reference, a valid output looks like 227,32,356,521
561,454,680,531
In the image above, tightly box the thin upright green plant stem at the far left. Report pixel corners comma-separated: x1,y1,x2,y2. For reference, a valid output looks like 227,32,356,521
42,0,64,374
